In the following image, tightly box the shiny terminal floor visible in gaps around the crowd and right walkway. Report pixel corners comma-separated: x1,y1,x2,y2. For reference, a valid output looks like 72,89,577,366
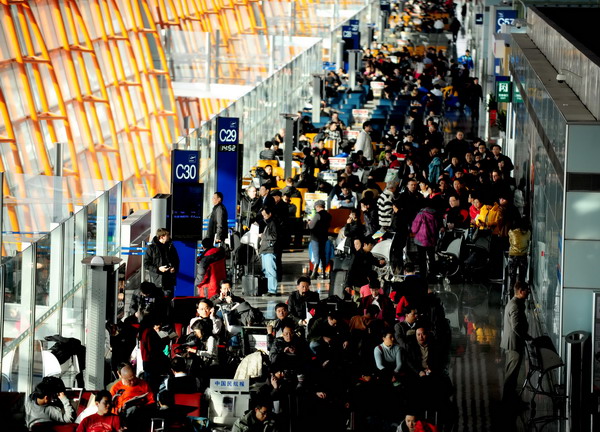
237,251,561,432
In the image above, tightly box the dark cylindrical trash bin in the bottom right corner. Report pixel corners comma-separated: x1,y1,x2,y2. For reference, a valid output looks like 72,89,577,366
565,331,592,432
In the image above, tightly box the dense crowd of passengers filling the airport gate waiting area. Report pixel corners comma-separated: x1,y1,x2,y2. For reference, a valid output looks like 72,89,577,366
21,1,530,432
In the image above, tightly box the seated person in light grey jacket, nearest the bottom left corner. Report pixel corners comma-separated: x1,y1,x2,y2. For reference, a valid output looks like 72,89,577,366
25,382,75,430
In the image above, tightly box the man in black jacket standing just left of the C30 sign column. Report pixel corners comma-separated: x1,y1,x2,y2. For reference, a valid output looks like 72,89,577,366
144,228,179,298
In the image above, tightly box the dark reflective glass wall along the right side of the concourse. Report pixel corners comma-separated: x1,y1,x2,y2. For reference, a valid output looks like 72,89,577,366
510,39,566,346
